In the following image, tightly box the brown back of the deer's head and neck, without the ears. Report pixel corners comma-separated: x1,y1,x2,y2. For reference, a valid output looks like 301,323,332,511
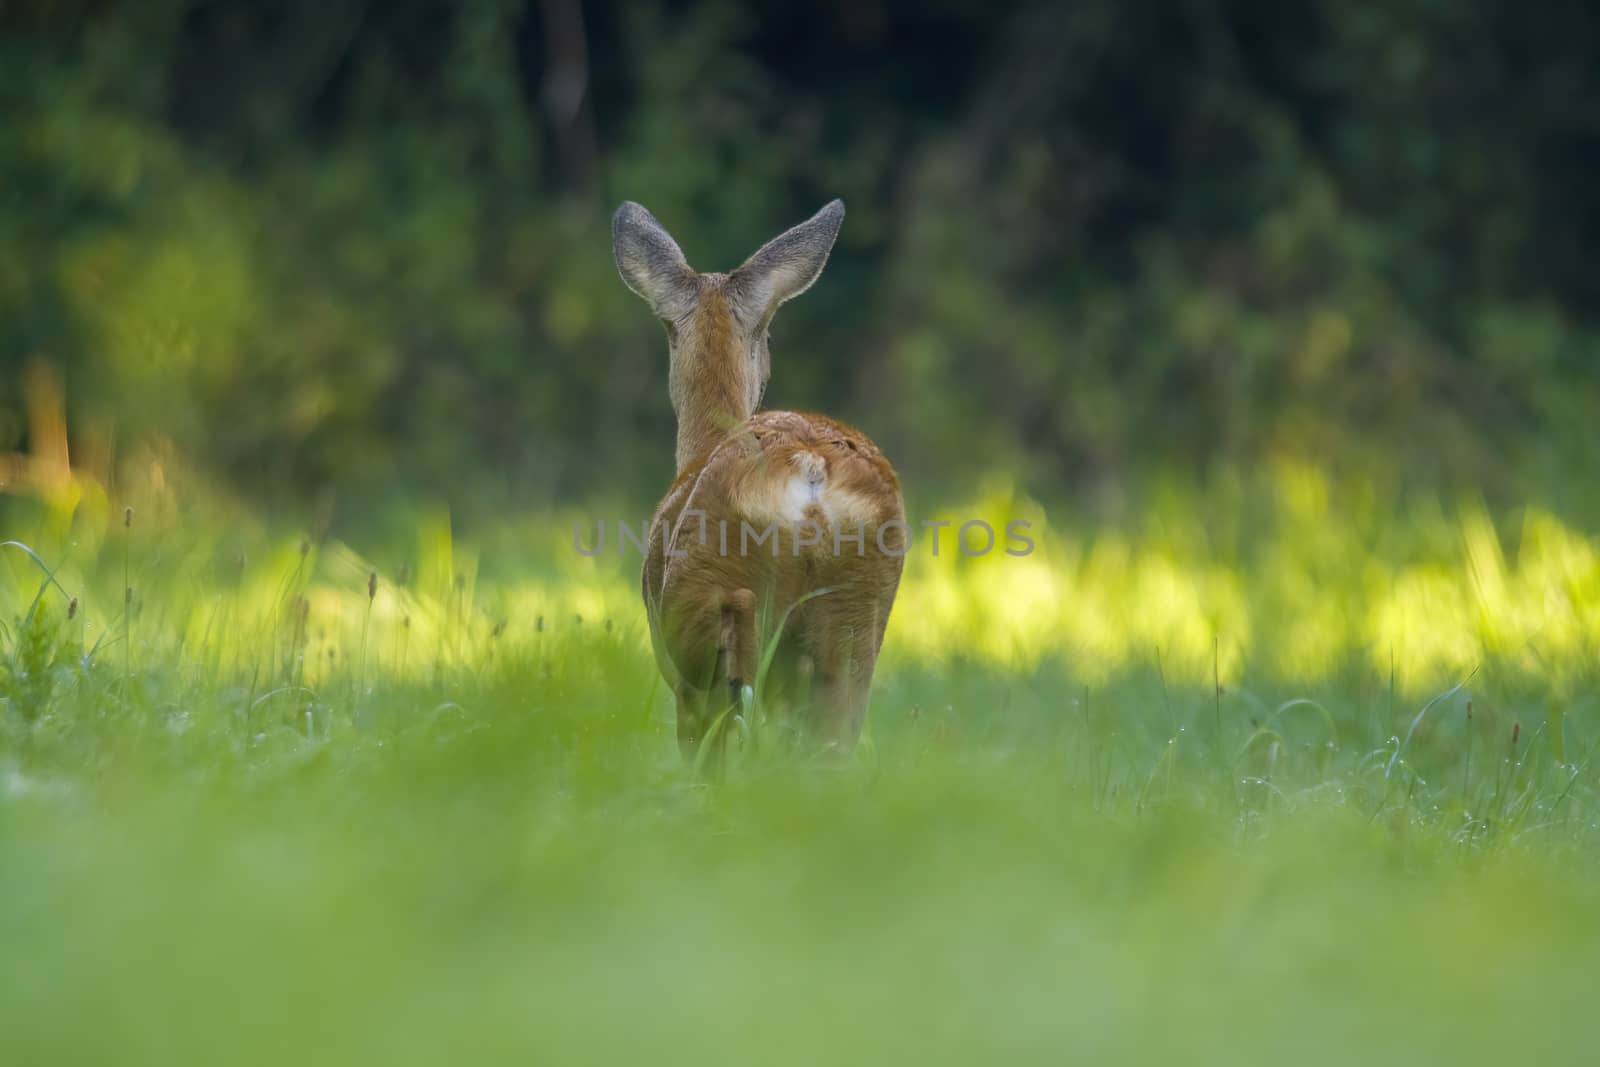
674,294,760,474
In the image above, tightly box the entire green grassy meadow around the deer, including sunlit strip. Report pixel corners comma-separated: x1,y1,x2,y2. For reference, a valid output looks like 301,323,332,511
0,469,1600,1064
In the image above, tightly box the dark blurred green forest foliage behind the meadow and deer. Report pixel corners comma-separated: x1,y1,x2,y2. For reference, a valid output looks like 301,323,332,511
0,0,1600,515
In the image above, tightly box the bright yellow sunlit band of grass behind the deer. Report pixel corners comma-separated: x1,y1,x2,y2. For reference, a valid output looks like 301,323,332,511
0,466,1600,691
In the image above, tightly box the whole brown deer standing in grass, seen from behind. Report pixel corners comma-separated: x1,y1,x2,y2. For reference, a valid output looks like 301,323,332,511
611,200,907,771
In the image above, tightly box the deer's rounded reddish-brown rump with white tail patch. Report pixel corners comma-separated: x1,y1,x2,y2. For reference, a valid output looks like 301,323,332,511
643,411,907,694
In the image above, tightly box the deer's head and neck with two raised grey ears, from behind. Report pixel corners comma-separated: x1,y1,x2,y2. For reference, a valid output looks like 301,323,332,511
611,200,845,470
